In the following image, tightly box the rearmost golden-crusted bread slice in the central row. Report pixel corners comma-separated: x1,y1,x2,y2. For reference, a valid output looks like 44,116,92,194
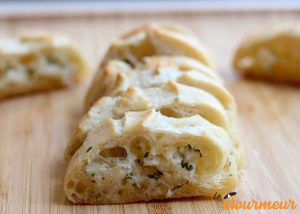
101,23,214,67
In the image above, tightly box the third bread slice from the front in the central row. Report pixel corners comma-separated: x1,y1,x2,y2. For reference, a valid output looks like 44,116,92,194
85,56,225,109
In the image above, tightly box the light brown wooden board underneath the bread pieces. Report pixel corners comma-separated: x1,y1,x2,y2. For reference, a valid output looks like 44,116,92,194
0,12,300,214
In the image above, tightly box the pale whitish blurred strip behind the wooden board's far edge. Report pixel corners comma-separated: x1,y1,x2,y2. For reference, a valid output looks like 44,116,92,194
0,0,300,17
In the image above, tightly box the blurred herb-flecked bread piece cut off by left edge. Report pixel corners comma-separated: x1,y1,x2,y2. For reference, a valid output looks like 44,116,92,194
0,34,88,98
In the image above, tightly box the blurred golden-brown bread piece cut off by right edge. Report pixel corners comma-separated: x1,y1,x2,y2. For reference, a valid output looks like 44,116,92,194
233,25,300,84
